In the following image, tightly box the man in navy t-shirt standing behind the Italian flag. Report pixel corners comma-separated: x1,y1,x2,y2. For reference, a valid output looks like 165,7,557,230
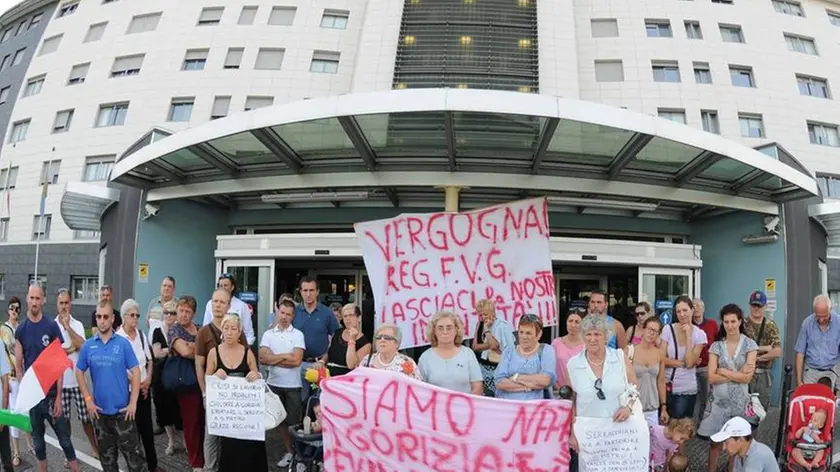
15,282,79,472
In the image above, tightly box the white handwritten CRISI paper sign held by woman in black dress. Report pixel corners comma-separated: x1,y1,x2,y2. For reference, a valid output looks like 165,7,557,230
205,375,265,441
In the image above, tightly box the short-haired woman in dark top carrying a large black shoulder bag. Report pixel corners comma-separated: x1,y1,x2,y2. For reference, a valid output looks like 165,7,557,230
169,296,204,471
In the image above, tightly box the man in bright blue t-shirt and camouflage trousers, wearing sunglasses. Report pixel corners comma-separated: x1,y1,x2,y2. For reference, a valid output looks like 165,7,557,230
76,300,148,472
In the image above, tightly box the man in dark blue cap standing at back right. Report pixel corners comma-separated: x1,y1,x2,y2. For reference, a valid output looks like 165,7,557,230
745,290,782,408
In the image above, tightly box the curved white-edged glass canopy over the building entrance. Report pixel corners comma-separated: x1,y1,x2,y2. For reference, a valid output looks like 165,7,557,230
111,89,818,213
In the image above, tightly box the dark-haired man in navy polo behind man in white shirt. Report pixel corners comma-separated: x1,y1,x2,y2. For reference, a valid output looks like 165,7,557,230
292,276,340,402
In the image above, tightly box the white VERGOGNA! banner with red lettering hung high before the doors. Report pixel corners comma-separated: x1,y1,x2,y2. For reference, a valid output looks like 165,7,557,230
356,198,557,348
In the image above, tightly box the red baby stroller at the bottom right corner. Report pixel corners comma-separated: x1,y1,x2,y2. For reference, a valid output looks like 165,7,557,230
782,384,835,472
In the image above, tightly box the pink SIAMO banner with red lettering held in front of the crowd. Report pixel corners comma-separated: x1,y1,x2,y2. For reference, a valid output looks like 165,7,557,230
321,367,572,472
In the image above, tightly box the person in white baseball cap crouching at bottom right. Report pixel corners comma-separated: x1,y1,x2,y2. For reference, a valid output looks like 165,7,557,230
711,416,779,472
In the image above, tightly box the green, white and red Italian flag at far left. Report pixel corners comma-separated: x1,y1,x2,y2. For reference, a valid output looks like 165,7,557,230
0,339,73,431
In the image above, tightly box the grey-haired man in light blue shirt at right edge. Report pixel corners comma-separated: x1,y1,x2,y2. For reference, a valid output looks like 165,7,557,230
793,295,840,389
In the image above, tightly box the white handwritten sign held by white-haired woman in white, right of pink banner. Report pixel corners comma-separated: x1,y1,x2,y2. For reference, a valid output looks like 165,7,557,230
575,415,650,472
